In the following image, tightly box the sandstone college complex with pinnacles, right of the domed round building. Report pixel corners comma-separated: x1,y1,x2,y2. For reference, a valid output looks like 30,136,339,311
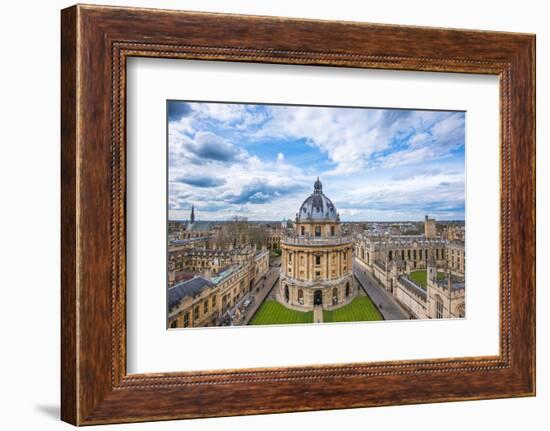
355,216,465,319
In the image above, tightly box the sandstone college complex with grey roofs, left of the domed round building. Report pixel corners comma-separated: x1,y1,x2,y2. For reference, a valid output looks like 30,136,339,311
167,207,269,328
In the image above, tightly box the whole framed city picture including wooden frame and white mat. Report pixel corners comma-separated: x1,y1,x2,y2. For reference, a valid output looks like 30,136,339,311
61,5,535,425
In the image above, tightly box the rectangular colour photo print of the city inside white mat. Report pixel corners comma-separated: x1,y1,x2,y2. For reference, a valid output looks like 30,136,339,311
166,100,466,329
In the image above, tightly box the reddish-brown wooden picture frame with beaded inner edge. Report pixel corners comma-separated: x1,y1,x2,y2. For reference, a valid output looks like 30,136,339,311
61,5,535,425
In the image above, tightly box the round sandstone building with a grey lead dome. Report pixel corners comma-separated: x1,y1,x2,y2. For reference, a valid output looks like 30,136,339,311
277,178,357,310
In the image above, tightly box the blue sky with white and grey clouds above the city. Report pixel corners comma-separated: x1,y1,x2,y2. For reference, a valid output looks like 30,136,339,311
167,101,465,221
